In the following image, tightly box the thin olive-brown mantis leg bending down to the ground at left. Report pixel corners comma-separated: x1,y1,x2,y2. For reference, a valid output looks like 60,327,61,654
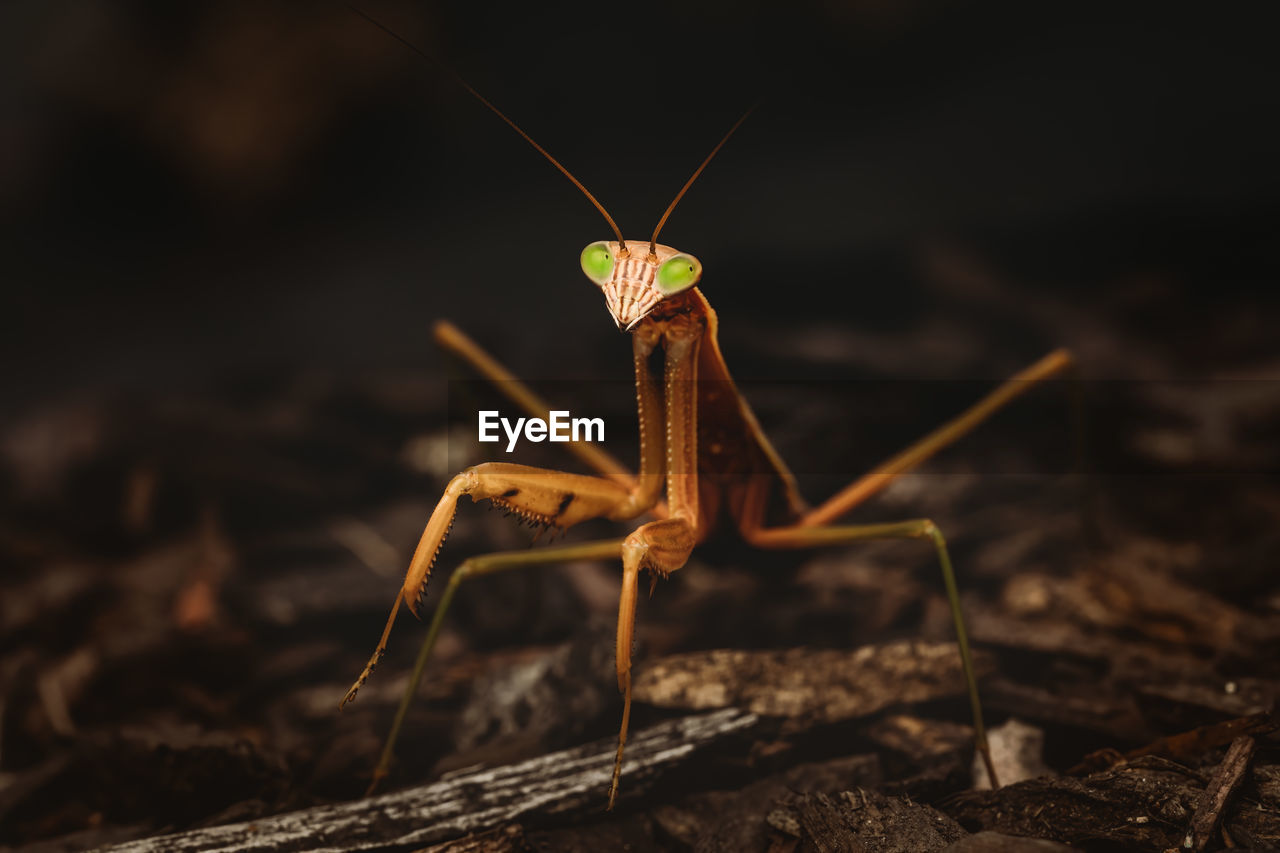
365,539,622,797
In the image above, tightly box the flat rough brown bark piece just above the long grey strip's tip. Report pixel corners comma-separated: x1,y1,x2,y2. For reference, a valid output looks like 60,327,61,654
634,640,991,724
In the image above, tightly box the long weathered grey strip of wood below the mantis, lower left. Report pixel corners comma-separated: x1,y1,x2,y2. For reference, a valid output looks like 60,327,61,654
102,710,759,853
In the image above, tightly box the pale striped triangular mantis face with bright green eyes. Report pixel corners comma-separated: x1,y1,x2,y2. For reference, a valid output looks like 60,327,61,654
581,240,703,332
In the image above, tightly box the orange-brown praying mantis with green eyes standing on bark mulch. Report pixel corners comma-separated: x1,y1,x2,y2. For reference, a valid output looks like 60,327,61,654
340,10,1071,808
